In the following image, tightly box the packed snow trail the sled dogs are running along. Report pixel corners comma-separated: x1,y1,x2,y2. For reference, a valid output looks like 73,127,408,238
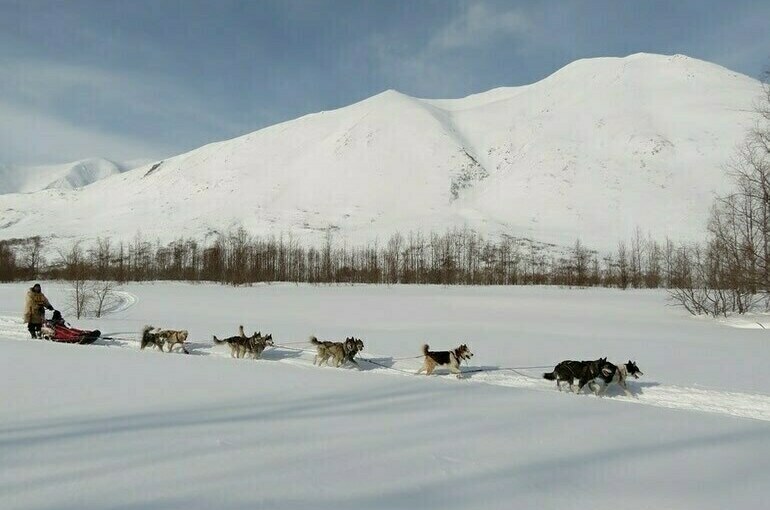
0,314,770,421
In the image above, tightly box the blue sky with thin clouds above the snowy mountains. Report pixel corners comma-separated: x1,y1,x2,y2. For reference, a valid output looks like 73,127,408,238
0,0,770,164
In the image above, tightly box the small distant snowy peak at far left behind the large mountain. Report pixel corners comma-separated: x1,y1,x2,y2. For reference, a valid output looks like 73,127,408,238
0,158,138,195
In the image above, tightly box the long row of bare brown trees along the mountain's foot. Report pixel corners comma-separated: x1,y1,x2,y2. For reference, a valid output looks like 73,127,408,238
0,228,692,288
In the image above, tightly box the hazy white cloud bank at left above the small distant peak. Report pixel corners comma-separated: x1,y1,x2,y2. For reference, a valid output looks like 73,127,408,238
0,59,243,164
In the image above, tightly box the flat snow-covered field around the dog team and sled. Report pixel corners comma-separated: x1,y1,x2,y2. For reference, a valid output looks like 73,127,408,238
0,283,770,510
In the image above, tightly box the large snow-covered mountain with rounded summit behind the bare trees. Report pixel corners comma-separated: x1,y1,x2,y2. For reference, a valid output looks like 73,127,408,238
0,54,761,248
